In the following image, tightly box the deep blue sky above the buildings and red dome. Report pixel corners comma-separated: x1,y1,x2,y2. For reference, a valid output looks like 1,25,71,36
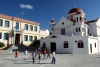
0,0,100,29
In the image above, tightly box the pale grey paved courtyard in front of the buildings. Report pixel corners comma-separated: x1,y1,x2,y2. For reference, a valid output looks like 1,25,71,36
0,51,100,67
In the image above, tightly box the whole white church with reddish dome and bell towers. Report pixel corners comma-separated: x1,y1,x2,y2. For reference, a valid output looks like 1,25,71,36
40,8,100,54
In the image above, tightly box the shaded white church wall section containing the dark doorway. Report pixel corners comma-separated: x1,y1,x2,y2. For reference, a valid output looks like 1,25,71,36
41,35,73,53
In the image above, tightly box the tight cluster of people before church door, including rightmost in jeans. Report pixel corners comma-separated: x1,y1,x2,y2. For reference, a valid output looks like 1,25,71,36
31,49,56,64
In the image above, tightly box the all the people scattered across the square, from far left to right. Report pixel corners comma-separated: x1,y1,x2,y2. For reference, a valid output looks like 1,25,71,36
10,48,56,64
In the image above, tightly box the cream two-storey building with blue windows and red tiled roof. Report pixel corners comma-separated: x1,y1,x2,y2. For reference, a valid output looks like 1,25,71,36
0,14,49,47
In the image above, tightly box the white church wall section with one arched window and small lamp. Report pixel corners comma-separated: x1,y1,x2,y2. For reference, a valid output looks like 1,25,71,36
73,36,88,54
